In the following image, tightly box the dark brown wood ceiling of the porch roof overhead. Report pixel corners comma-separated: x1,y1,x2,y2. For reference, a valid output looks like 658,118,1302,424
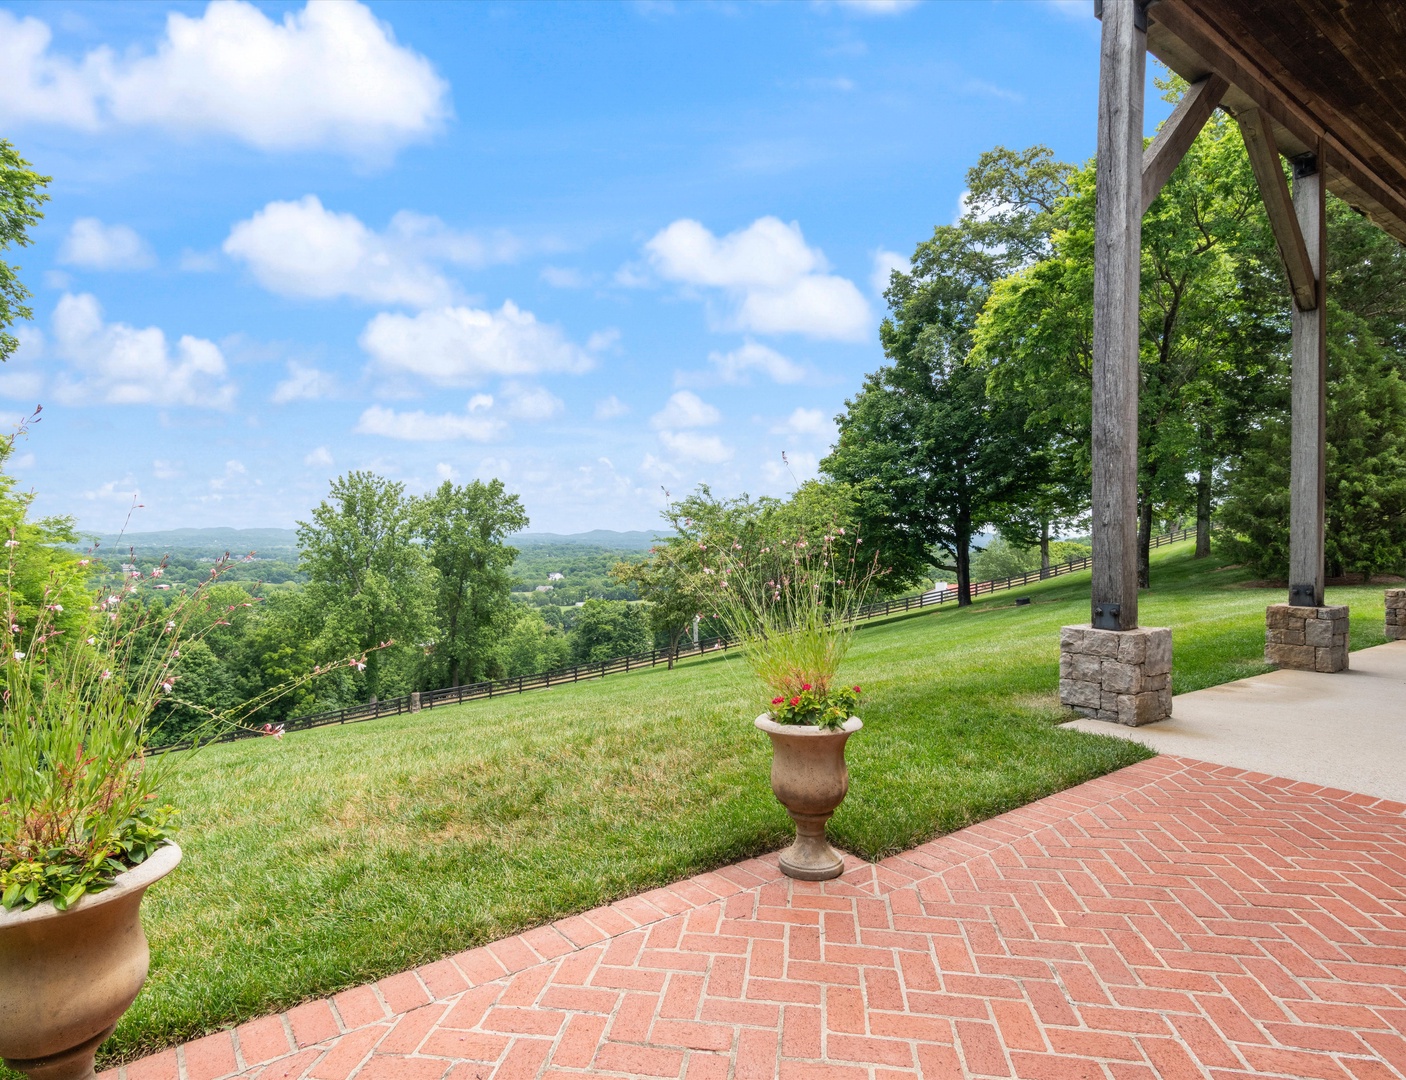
1147,0,1406,243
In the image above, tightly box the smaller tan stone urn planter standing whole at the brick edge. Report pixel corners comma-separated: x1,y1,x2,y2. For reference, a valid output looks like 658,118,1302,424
756,713,863,882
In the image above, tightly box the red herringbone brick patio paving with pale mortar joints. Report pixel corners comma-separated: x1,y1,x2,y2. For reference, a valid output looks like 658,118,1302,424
104,757,1406,1080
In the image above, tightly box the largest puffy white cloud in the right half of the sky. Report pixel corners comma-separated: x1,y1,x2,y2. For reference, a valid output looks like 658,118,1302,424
644,217,873,340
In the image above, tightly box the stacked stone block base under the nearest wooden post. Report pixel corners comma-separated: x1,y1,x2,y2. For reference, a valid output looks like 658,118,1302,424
1059,626,1171,727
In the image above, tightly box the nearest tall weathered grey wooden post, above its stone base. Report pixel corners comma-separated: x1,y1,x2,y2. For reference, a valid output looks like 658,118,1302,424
1091,0,1147,630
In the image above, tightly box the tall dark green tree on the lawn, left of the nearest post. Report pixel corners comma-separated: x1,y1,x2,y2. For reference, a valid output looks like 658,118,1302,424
821,146,1069,605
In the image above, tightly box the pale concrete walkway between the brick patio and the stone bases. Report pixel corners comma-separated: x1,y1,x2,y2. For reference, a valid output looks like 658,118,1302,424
1066,641,1406,803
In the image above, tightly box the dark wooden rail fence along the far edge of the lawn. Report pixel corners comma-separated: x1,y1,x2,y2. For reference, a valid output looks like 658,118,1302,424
149,529,1197,754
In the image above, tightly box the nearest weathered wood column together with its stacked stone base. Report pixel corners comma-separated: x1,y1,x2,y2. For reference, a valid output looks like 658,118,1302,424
1059,0,1169,724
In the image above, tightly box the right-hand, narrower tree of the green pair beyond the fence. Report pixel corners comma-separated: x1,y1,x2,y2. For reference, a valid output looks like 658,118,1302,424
416,480,527,686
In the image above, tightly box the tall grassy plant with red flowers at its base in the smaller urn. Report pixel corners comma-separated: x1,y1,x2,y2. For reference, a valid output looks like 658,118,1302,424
699,526,880,731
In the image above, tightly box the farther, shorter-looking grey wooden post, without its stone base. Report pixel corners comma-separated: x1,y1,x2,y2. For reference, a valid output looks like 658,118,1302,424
1289,156,1327,608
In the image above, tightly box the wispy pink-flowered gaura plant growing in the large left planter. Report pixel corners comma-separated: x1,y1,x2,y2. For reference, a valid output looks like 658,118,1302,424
0,450,366,911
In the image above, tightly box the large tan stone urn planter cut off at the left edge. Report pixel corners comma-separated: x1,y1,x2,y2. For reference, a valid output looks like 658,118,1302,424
0,844,180,1080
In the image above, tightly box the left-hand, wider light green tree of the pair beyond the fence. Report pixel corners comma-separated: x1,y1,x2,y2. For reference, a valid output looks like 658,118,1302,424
298,471,434,696
